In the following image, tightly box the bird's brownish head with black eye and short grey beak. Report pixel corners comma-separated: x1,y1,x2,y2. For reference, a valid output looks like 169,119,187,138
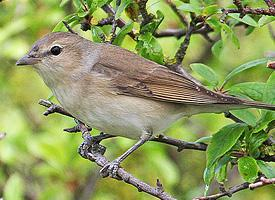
16,32,98,86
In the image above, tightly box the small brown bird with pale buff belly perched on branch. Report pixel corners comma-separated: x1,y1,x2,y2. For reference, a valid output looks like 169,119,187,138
16,32,275,176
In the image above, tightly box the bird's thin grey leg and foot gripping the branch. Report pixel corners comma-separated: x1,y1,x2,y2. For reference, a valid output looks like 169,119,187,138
100,132,153,178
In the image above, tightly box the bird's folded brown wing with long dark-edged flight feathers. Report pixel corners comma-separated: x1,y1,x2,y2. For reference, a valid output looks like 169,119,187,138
92,44,243,105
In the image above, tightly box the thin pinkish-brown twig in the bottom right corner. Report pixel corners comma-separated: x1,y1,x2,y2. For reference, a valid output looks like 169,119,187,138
194,177,275,200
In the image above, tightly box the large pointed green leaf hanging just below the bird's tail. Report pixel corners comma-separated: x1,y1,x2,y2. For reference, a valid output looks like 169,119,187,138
206,123,247,168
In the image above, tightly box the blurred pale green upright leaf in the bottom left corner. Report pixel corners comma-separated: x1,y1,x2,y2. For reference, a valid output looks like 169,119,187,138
4,173,25,200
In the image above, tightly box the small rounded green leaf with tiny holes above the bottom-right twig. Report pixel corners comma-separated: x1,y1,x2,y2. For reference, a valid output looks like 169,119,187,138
238,156,259,183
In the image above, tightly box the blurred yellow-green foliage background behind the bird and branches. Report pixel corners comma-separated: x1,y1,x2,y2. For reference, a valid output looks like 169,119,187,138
0,0,275,200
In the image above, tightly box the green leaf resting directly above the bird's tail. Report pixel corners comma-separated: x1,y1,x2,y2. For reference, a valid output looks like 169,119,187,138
229,82,265,101
